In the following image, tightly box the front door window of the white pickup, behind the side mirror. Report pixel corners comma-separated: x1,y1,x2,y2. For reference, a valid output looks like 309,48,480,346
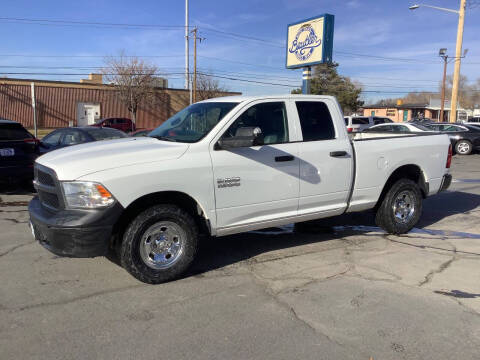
223,101,288,145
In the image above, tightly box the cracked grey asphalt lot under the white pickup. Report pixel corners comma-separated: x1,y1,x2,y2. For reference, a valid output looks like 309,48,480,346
0,154,480,359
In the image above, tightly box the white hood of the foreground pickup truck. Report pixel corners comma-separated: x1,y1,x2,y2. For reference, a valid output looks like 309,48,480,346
36,137,188,180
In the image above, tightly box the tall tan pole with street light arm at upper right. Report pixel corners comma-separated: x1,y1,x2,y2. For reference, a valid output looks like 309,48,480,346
409,0,467,122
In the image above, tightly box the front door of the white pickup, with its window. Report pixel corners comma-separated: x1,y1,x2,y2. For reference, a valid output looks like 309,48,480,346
211,101,300,229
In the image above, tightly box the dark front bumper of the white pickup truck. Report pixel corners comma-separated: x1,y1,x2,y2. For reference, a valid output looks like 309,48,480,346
28,197,123,257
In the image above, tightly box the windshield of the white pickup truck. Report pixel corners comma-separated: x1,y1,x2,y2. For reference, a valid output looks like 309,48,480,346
148,102,238,143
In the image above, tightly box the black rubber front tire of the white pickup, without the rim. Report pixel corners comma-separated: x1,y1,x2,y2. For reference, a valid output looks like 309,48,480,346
120,204,198,284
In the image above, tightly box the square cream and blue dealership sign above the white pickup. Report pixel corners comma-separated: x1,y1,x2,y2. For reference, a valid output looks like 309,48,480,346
287,14,334,69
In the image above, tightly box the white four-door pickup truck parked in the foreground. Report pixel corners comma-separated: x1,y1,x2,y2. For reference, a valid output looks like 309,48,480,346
29,95,451,283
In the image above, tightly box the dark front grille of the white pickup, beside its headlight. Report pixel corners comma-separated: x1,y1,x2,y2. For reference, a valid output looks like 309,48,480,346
34,164,62,210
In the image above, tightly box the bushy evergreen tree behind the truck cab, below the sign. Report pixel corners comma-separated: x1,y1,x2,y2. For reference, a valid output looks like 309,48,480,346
292,63,364,114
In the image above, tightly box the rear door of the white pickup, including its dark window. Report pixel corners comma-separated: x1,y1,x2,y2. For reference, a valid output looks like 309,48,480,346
295,100,353,216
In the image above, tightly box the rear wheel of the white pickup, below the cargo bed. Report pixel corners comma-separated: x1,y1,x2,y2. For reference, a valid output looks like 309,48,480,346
375,179,422,234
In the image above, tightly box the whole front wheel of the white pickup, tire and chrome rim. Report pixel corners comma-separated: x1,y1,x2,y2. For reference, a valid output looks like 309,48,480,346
120,205,198,284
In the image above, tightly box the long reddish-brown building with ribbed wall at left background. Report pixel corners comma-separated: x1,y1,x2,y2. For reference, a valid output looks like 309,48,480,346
0,74,238,128
